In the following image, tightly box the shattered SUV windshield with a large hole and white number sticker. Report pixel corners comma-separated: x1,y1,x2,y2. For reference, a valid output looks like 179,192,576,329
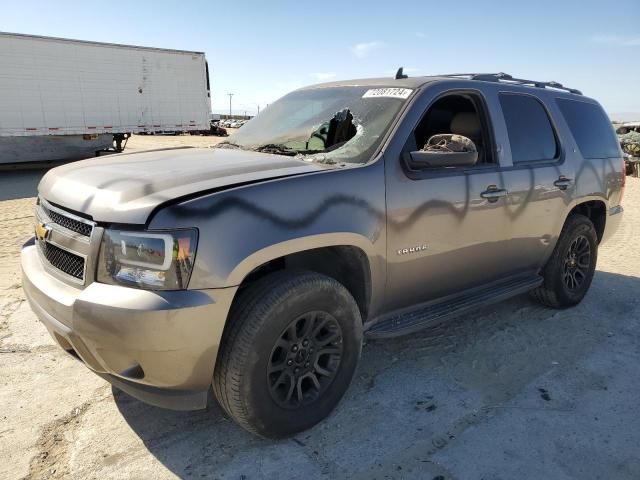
217,87,412,163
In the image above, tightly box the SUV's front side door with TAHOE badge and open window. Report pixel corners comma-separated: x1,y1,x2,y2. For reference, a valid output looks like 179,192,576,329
385,90,510,310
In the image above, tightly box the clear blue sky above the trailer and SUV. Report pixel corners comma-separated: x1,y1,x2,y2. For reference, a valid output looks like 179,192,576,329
5,0,640,119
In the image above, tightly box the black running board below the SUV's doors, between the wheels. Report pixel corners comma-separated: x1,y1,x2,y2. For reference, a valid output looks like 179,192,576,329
365,275,543,338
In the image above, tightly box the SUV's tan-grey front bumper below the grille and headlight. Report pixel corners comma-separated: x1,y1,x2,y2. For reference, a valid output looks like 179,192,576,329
21,245,237,410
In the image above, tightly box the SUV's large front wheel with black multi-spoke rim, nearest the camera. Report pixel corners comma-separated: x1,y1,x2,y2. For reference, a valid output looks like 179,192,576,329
213,272,362,438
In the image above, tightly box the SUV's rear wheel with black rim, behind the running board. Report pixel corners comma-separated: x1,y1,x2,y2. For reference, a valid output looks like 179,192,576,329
532,214,598,308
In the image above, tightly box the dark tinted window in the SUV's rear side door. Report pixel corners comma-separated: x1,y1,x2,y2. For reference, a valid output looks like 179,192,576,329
500,93,558,163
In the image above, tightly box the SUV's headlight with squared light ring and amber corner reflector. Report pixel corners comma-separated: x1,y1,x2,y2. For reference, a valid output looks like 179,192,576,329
97,230,198,290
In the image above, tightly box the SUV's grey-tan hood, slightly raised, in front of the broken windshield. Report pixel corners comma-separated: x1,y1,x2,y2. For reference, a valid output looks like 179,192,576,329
38,148,331,224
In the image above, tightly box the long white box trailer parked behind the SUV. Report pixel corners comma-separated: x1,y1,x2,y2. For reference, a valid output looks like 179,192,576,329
0,32,211,164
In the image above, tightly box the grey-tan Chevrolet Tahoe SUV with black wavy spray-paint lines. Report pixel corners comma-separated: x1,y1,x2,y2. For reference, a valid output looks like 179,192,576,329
22,72,625,437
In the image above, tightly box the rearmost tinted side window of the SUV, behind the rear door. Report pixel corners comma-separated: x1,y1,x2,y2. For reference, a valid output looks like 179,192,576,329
557,98,620,158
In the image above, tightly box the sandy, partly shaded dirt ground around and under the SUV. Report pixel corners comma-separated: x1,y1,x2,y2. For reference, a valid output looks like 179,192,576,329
0,137,640,480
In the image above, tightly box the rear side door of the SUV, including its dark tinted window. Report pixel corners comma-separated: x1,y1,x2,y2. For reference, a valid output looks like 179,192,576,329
494,90,576,273
